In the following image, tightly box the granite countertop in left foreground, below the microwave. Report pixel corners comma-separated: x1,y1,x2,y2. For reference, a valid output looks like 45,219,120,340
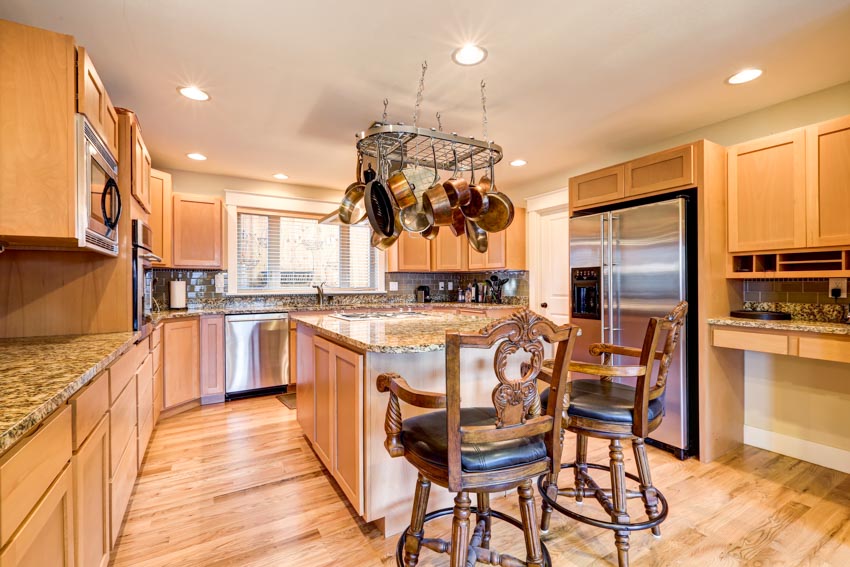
0,332,137,453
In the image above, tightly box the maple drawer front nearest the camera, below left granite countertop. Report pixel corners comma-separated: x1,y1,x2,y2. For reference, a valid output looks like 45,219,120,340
0,405,72,547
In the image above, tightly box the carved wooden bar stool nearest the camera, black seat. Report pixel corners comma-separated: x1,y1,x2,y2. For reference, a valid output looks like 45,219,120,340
377,309,578,567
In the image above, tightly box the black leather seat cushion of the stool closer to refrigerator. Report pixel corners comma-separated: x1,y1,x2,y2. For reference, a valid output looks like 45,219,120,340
540,380,664,423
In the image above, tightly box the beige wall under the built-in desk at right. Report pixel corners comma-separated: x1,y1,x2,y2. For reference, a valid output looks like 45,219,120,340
744,352,850,451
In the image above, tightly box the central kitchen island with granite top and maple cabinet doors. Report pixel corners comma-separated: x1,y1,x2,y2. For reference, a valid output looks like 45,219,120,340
293,312,516,536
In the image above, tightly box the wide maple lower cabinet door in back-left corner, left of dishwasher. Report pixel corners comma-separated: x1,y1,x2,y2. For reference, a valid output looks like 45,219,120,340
161,317,201,409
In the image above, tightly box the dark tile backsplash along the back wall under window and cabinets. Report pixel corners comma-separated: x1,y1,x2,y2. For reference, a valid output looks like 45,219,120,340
153,269,528,308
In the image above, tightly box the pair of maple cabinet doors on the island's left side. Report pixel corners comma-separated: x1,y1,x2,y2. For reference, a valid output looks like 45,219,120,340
313,337,363,514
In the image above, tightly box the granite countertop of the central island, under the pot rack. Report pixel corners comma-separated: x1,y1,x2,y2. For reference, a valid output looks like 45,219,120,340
293,313,492,353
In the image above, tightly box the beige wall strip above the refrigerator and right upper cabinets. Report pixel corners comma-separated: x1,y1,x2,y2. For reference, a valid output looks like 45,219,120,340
511,82,850,204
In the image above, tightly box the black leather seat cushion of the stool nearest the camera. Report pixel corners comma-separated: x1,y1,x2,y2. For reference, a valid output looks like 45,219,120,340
401,408,546,472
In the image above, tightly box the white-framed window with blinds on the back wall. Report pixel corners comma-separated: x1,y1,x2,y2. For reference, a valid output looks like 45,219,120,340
236,211,383,293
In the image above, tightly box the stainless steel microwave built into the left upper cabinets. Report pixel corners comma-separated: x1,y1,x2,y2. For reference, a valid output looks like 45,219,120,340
76,114,121,256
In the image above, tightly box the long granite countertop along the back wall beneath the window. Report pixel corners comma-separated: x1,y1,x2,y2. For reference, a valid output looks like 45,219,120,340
152,302,523,325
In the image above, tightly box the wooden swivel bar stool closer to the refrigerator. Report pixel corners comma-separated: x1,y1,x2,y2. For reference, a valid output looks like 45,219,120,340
538,301,688,567
